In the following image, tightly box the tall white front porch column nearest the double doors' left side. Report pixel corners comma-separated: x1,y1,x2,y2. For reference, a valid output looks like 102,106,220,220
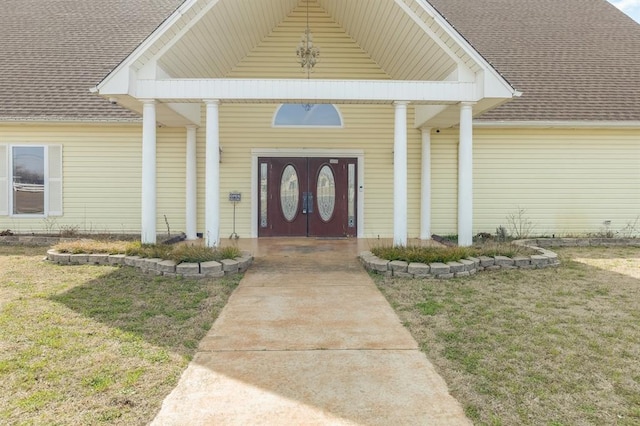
204,100,220,247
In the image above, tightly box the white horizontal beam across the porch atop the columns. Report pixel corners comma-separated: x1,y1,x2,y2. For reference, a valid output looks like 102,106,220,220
134,78,480,103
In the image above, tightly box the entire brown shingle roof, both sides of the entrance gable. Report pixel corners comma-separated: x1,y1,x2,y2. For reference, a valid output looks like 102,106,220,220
0,0,640,121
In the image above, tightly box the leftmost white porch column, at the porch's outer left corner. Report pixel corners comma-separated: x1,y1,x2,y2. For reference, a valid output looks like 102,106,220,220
141,100,156,244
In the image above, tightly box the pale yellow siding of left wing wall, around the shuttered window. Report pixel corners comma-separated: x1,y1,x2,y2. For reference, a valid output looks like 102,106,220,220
0,125,190,233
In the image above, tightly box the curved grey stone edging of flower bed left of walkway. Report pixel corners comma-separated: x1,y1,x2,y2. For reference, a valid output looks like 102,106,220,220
47,249,253,278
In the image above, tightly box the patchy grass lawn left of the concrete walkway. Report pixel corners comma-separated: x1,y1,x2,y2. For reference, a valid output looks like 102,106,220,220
0,246,241,425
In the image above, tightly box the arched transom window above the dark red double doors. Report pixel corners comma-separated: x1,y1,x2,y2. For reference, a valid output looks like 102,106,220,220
273,104,342,127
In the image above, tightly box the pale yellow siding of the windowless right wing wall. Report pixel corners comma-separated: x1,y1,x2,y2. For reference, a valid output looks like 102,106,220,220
432,129,640,235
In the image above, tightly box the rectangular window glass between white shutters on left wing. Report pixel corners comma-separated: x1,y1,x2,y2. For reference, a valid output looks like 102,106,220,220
12,146,44,214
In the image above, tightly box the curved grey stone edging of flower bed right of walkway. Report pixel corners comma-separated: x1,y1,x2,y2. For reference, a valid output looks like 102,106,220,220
359,240,560,279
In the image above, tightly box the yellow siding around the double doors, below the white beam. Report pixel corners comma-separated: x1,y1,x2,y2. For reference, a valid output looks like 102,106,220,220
206,104,421,237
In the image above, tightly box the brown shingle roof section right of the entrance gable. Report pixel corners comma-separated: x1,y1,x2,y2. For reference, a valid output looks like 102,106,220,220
429,0,640,121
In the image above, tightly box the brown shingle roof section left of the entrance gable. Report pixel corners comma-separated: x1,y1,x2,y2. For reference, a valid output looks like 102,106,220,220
0,0,182,121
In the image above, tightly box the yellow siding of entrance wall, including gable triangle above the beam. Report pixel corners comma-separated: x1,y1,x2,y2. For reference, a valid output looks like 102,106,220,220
208,8,421,238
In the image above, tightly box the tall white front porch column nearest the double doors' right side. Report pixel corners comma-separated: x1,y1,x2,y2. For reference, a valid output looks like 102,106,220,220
393,102,409,246
